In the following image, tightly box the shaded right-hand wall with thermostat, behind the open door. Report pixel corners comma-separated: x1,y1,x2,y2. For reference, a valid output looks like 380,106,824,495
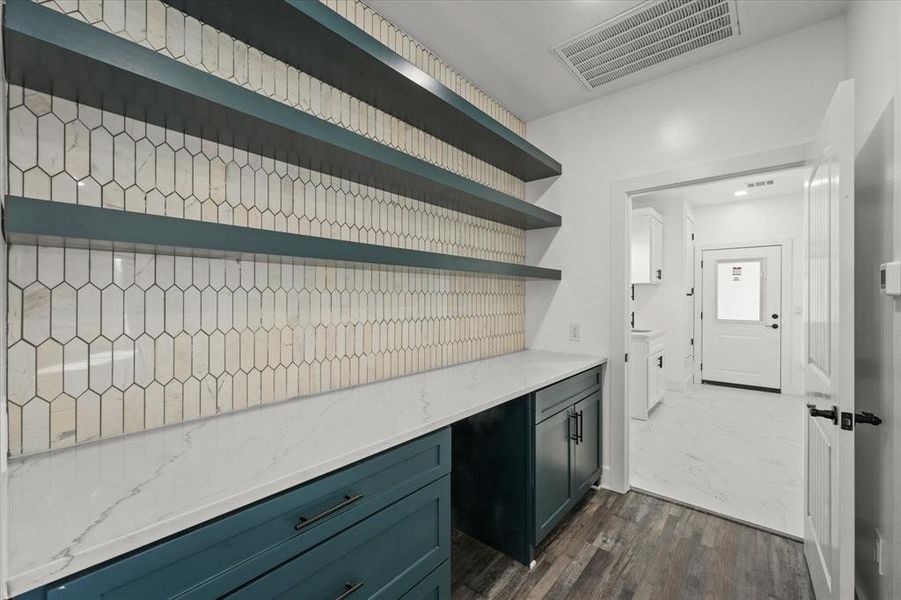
847,0,901,600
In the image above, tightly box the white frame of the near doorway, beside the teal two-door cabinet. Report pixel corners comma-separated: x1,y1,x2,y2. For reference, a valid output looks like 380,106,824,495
602,142,810,492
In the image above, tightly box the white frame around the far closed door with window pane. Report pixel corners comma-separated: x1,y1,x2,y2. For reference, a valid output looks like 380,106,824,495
692,238,803,395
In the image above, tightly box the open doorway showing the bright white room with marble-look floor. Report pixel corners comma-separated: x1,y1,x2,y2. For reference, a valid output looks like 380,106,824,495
627,167,807,538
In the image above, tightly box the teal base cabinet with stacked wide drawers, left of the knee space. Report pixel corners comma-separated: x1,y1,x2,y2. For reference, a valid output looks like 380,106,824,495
14,429,451,600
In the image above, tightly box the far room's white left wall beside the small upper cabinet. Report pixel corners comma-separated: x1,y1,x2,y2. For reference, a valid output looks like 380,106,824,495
632,191,688,390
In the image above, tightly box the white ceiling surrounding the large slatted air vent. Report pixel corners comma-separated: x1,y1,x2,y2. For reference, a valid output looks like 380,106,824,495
365,0,846,121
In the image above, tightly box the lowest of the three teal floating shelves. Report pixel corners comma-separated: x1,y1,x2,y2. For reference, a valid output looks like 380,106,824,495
3,196,561,280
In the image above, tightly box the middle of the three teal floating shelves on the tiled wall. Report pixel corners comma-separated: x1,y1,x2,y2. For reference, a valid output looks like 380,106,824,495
4,0,561,229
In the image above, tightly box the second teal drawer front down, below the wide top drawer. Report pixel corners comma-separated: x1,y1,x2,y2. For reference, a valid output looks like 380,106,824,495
226,476,450,600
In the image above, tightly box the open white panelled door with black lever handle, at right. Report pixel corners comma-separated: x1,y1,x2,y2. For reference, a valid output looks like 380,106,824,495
804,81,854,600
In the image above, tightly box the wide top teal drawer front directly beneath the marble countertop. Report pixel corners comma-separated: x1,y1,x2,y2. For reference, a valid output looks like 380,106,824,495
46,429,451,600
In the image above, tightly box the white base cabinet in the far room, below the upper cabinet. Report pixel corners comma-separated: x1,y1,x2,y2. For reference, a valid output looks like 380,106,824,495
629,329,666,421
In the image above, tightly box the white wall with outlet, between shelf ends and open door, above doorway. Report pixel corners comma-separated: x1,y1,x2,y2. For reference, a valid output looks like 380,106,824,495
526,19,844,480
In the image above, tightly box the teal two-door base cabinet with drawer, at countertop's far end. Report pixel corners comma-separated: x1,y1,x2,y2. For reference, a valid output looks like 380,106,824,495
452,367,602,565
